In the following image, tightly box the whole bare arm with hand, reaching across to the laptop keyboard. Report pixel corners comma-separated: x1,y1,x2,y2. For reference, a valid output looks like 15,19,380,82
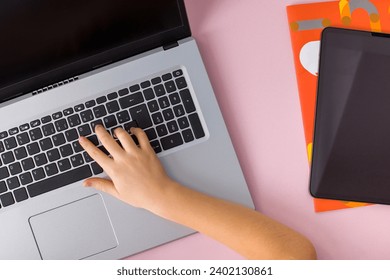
80,126,316,259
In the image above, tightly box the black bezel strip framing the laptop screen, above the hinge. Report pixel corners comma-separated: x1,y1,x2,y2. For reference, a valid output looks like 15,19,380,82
0,0,191,103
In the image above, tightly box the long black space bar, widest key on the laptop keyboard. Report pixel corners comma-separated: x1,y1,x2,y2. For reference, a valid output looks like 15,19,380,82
27,165,92,197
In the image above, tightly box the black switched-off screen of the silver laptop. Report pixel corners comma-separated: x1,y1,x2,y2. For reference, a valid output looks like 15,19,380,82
0,0,186,101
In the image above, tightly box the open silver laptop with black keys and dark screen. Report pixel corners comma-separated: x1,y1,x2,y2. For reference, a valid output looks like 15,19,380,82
0,0,253,259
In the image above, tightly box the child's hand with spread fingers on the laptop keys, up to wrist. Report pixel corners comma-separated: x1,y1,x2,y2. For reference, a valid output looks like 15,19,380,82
79,125,171,210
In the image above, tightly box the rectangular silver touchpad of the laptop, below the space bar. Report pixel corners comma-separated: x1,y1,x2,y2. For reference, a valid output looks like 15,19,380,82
29,194,118,259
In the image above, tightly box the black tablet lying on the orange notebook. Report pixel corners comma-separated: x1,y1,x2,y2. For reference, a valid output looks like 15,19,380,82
310,28,390,204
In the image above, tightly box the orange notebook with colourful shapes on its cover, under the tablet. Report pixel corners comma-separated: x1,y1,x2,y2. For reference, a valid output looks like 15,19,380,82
287,0,390,212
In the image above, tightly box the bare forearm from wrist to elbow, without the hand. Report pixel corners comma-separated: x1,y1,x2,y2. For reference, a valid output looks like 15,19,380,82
151,182,315,259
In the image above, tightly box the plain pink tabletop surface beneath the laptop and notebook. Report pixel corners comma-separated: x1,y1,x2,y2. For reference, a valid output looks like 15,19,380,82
130,0,390,259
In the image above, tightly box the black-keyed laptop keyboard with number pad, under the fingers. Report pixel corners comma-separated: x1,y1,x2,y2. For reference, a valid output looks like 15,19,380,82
0,69,205,208
